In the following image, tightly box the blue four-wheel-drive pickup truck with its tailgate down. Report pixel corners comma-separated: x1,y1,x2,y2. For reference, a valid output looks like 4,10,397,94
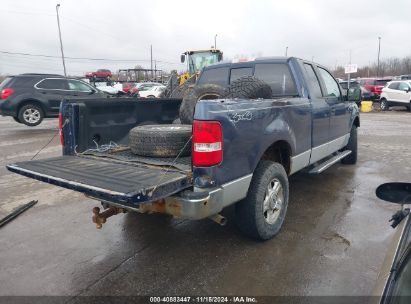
7,57,360,240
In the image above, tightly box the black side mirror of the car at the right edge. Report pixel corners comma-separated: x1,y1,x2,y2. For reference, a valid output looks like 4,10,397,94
375,183,411,204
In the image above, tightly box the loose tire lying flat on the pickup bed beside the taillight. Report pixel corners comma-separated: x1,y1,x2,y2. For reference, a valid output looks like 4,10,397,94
129,124,192,157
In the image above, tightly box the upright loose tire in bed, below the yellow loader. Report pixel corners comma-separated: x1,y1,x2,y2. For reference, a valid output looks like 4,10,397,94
180,84,226,124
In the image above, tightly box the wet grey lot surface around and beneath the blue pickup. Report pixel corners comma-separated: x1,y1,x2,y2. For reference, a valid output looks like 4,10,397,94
0,111,411,296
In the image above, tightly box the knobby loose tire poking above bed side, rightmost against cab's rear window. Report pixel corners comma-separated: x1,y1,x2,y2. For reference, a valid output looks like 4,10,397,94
226,76,273,99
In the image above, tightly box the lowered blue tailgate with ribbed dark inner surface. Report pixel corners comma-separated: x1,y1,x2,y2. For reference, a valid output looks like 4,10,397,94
7,156,191,207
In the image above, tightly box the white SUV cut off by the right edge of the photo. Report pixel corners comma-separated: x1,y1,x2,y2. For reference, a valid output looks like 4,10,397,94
380,80,411,111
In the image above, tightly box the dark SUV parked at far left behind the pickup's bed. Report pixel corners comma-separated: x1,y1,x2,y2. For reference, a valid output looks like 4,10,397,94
0,74,105,127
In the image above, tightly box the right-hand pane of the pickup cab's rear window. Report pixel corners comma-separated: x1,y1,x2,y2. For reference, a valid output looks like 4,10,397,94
254,63,298,96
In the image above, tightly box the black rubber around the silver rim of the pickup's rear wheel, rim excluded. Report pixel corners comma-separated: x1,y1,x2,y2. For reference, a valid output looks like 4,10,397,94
236,160,289,241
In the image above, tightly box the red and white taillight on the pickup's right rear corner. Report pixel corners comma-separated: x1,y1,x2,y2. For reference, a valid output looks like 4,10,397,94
192,120,223,167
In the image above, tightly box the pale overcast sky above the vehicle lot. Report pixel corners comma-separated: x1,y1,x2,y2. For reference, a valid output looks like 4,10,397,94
0,0,411,75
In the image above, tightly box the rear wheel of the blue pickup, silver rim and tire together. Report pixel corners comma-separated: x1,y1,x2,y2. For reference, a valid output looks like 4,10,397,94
236,160,289,240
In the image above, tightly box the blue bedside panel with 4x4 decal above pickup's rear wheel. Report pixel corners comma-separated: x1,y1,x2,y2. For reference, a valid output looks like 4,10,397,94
193,98,311,185
